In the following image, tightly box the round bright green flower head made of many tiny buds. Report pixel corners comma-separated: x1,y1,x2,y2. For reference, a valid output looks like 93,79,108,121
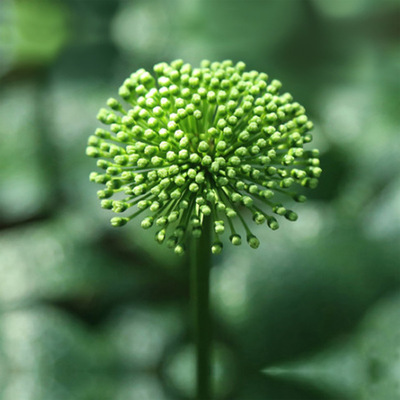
87,60,321,254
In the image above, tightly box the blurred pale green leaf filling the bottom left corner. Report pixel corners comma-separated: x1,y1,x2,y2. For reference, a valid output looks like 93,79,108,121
0,307,114,400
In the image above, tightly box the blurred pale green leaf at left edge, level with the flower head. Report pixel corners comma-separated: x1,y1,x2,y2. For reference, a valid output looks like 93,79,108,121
0,81,51,221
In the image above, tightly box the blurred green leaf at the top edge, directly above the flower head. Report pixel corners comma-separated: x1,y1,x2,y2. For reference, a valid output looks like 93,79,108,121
112,0,301,63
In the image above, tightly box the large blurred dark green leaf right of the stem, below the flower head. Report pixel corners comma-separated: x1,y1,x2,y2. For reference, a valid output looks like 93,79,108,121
214,222,400,369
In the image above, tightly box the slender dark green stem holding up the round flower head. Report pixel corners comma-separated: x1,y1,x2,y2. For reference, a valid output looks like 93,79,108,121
190,217,212,400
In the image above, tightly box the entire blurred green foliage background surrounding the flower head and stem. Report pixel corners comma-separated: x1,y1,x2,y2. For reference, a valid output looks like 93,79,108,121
0,0,400,400
